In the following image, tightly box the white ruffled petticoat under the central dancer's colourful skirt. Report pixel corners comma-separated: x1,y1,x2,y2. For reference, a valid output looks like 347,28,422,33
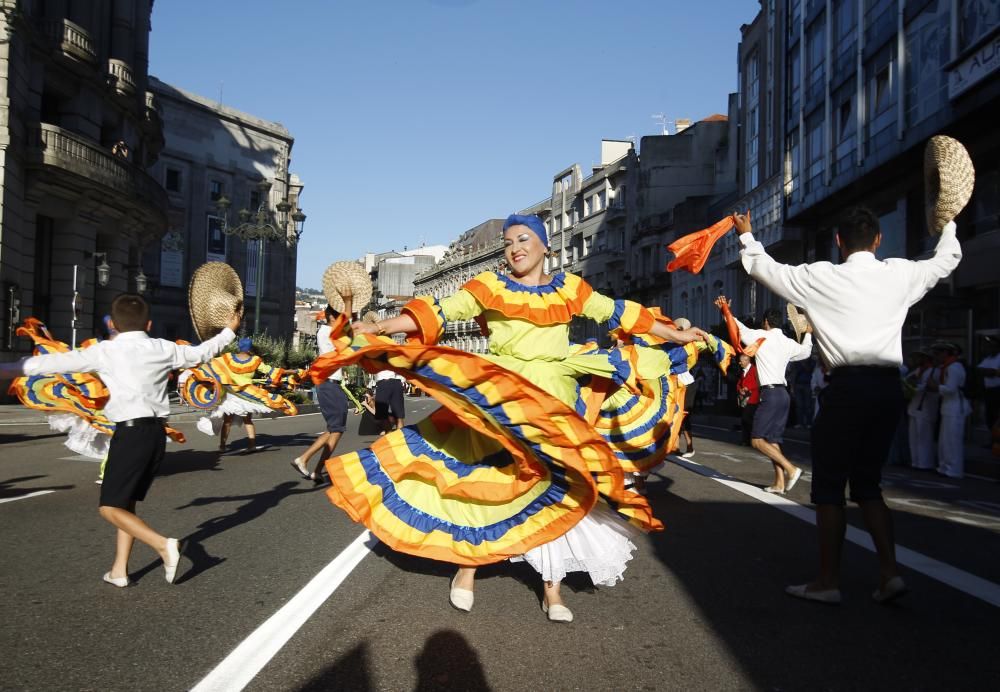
510,502,637,586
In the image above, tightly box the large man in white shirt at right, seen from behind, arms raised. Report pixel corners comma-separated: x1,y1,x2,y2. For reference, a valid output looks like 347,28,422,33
734,209,962,603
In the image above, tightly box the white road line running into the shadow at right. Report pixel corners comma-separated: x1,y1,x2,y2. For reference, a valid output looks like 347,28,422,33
670,456,1000,607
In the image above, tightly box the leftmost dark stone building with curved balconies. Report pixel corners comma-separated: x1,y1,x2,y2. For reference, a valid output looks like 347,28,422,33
0,0,167,360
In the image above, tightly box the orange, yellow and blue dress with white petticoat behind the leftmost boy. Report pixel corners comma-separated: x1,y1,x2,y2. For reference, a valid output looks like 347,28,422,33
8,317,185,459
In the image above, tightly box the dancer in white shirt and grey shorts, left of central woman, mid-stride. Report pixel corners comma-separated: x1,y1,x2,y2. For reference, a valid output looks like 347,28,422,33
291,296,351,483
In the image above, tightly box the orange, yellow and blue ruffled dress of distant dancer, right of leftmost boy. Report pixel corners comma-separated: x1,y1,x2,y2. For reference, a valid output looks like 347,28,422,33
177,339,305,435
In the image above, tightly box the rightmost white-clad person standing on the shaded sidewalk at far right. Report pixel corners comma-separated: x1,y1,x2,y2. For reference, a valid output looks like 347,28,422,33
931,342,972,478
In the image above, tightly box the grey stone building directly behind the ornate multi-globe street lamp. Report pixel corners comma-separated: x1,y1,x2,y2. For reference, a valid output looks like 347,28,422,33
144,77,303,339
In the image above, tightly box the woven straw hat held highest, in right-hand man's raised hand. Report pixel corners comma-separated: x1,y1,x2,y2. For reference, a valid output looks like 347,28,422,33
924,135,976,234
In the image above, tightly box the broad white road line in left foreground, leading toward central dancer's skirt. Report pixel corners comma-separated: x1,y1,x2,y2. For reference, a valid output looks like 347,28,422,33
191,531,378,692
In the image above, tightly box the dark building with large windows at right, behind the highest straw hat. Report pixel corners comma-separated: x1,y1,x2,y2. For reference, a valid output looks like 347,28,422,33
726,0,1000,360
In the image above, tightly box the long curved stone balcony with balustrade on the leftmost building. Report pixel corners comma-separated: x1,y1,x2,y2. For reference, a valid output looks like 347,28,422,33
27,123,167,222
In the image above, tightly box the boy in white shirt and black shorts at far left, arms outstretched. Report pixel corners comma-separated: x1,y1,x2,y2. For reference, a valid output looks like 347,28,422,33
0,293,242,587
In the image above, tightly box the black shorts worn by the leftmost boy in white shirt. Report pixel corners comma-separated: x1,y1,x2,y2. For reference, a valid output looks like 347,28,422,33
100,418,167,509
